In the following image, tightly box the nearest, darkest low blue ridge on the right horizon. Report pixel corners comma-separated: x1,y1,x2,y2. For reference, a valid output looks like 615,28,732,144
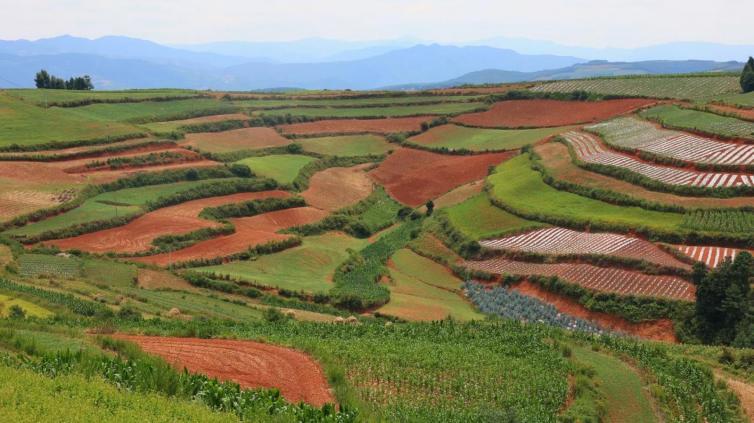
386,60,744,90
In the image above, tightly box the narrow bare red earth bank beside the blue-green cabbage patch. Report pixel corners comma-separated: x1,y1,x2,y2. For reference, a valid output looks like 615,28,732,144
512,281,676,342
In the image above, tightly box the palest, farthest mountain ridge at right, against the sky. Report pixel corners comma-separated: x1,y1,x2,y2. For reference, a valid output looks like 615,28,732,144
471,37,754,62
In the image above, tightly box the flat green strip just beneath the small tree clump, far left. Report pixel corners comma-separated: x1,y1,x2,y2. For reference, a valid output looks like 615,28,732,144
6,89,200,106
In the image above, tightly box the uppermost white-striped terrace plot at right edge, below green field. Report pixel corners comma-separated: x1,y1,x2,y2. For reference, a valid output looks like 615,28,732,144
586,118,754,165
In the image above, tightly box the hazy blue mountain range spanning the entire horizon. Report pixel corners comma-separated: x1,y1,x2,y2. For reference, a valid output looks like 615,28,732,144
0,36,754,90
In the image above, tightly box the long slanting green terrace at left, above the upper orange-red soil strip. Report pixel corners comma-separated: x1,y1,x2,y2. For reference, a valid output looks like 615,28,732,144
6,179,236,236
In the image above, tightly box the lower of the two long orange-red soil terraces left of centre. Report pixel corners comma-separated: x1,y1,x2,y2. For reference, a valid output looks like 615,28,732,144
132,207,327,266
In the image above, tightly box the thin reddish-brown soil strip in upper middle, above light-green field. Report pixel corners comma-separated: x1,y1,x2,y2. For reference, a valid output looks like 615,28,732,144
278,116,434,135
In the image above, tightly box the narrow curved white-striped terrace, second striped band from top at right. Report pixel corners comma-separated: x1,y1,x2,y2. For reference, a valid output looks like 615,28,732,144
563,131,754,188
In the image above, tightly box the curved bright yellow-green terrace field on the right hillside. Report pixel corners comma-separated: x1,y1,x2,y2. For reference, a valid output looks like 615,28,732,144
488,155,684,231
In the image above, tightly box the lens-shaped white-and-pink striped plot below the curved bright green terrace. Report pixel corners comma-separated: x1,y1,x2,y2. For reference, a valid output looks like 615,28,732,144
479,228,688,268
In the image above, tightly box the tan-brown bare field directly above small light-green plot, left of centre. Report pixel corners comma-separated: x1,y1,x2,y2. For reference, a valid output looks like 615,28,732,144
181,128,290,153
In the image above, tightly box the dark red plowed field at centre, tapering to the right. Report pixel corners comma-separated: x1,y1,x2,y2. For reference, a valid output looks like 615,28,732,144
369,148,516,207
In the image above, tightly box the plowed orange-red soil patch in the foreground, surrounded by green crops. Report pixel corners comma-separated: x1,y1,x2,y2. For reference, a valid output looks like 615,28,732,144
114,335,335,407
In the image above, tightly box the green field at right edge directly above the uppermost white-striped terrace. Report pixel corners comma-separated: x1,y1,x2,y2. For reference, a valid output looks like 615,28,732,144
640,105,754,140
